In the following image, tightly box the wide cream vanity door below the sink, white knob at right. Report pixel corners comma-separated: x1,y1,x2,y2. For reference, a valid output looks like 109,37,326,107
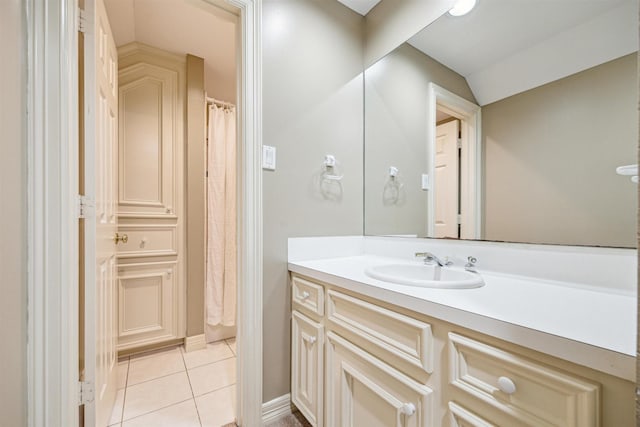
325,332,434,427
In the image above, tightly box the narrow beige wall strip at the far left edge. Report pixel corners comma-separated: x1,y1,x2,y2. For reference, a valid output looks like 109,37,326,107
0,0,27,426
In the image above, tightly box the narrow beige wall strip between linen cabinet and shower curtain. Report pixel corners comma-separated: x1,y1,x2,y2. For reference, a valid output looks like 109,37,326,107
185,55,207,337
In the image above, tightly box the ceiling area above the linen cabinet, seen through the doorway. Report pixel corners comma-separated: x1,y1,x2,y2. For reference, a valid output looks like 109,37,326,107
105,0,238,102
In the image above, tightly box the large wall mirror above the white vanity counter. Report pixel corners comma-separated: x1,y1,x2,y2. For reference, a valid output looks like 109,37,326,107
364,0,638,247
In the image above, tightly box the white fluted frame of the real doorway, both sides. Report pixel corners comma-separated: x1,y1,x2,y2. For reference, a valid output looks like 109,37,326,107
24,0,263,427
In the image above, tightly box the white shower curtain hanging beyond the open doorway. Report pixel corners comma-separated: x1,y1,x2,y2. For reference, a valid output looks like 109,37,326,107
206,105,237,326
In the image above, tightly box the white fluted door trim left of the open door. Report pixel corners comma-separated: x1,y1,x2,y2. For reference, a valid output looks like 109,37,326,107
25,0,79,427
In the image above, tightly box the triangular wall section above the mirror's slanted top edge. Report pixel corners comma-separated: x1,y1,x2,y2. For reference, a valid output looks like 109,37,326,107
364,0,454,67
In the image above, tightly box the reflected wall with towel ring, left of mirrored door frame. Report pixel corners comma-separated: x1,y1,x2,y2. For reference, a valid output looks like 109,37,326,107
364,43,475,237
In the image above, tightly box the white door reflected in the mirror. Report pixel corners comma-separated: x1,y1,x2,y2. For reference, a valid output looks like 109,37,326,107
434,120,460,238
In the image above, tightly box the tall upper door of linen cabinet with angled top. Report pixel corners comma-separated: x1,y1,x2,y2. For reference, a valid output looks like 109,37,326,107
118,62,184,215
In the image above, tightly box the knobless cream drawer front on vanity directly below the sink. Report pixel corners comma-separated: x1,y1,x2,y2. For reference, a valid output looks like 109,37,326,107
327,290,433,373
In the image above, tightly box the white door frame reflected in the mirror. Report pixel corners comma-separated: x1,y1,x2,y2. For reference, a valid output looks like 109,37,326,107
427,82,482,239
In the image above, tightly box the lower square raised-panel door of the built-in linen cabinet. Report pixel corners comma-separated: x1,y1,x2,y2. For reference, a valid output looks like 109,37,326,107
118,262,178,350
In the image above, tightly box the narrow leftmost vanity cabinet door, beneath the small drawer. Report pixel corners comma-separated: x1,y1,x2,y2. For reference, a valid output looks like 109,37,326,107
291,311,324,427
